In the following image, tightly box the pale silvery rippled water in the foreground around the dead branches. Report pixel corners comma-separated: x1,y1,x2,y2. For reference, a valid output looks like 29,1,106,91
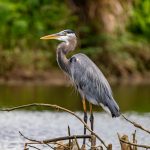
0,111,150,150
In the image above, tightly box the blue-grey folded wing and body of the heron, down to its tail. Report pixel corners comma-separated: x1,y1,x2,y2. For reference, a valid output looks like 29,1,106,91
70,54,119,116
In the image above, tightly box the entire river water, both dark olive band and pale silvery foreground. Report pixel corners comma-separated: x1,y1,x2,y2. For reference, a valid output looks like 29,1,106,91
0,85,150,150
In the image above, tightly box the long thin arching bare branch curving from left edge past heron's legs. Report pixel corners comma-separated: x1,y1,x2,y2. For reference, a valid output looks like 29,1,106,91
1,103,107,149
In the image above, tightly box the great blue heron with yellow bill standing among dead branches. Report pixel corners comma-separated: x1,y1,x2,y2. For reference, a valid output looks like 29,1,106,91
41,29,120,148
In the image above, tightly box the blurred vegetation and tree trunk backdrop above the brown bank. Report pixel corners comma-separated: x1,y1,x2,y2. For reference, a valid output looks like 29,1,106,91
0,0,150,80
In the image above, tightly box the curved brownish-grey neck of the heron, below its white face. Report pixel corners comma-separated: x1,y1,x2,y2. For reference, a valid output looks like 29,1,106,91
57,39,76,74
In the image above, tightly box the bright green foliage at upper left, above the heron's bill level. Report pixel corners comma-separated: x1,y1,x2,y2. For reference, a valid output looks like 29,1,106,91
0,0,77,49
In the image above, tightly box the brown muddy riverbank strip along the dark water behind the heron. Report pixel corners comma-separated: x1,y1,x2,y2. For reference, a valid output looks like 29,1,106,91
0,69,150,86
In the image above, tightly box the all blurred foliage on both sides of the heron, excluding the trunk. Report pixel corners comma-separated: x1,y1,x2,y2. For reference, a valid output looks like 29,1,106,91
0,0,150,77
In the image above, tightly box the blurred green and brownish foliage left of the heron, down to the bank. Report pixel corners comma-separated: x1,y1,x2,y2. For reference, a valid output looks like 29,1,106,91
0,0,77,75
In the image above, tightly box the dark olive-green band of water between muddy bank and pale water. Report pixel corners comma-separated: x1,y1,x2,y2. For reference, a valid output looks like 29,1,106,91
0,85,150,112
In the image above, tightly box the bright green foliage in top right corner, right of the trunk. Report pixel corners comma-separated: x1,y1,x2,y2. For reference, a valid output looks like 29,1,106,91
129,0,150,40
